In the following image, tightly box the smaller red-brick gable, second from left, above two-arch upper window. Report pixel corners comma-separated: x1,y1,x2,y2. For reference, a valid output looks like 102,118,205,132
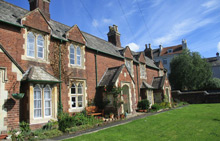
66,25,86,44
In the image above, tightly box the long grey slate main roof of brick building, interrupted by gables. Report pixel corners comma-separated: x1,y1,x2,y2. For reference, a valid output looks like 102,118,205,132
0,0,158,66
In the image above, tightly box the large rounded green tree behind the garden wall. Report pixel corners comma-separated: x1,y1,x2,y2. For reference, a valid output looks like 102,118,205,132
169,50,212,90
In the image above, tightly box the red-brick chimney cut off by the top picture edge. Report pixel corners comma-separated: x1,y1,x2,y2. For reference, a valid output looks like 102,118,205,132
28,0,50,20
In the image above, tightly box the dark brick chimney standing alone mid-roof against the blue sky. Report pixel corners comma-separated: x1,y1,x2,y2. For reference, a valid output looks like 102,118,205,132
107,25,121,47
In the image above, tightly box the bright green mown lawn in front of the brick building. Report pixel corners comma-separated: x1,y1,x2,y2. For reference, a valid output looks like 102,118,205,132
65,104,220,141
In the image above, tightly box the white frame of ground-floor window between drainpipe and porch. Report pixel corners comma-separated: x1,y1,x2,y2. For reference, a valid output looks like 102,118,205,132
70,82,85,109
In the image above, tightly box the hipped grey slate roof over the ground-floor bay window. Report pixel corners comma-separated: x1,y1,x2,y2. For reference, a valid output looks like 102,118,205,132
21,66,60,83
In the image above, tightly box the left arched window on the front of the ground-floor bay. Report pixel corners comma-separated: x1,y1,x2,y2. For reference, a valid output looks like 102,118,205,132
34,85,42,118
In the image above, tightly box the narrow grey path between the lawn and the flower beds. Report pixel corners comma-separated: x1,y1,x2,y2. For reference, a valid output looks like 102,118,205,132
46,106,184,141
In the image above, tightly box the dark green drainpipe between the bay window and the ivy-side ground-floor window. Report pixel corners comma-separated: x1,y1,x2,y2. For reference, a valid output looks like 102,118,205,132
58,40,63,113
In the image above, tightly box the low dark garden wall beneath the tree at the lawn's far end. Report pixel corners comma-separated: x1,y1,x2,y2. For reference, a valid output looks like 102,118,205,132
172,91,220,104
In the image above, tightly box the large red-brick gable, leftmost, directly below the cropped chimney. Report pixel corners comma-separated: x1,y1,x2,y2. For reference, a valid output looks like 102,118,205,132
21,9,51,33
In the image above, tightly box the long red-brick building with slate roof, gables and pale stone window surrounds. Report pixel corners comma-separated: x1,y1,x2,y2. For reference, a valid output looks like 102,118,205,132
0,0,171,133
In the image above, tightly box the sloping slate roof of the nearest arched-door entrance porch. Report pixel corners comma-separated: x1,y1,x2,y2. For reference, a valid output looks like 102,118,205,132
99,65,125,86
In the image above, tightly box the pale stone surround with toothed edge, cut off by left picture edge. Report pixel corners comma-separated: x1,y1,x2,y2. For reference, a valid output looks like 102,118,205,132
0,69,8,134
